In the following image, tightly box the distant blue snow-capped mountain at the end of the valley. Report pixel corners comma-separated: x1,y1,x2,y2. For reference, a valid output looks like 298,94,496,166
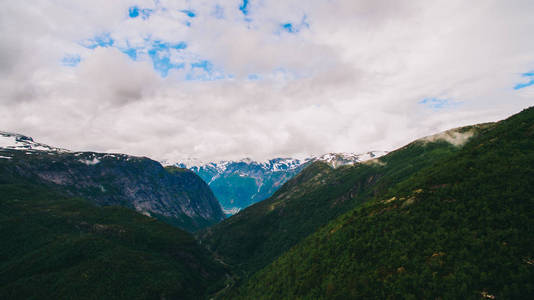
162,151,387,215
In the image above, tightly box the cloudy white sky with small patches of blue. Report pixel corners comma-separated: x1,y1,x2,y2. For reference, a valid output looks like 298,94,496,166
0,0,534,161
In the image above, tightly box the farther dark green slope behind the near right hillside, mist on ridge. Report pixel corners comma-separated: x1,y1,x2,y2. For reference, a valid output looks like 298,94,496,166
198,124,491,277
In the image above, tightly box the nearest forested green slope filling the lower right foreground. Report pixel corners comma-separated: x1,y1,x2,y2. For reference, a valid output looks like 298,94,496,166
234,108,534,299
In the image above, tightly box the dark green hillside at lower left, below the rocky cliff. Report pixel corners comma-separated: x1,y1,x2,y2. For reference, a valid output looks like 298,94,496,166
0,177,225,299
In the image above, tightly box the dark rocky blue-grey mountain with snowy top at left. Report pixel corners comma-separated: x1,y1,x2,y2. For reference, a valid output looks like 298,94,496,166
0,133,224,231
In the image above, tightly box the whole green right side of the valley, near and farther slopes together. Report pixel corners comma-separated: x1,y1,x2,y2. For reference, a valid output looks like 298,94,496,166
202,108,534,299
